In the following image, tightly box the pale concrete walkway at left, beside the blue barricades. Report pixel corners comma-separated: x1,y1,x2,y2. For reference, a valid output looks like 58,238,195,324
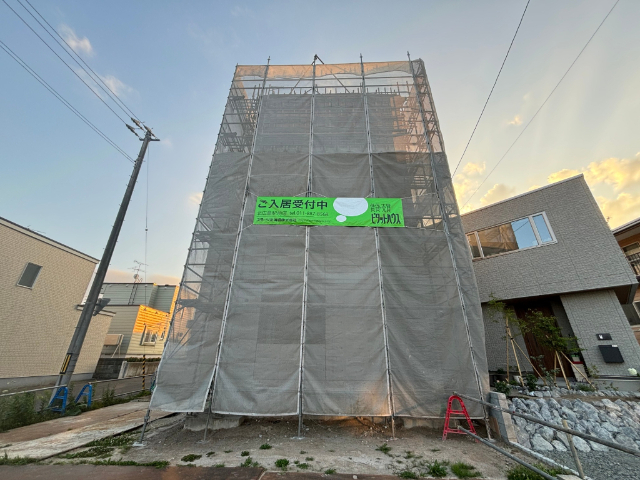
0,401,171,458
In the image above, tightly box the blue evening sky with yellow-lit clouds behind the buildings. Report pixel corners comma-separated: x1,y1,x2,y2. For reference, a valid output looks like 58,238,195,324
0,0,640,283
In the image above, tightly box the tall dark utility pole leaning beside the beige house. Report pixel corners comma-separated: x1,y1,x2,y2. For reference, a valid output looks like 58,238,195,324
52,128,159,399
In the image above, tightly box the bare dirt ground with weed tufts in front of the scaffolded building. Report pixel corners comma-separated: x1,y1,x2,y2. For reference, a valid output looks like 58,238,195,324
43,415,532,480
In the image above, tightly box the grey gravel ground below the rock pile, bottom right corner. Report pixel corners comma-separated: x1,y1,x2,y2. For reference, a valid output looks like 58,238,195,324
544,449,640,480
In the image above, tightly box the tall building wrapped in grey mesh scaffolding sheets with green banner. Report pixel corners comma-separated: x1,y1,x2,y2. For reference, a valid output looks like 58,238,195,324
151,57,488,424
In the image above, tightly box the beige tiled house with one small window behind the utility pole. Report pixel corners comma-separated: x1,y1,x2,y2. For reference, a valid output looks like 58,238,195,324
0,217,113,389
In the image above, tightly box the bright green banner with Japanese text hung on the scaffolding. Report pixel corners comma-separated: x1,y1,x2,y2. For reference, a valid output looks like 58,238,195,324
253,197,404,227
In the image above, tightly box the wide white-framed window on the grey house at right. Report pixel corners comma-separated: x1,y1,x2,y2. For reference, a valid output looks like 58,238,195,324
467,212,555,258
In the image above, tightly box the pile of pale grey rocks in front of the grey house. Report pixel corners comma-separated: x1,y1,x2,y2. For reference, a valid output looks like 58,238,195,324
509,397,640,452
